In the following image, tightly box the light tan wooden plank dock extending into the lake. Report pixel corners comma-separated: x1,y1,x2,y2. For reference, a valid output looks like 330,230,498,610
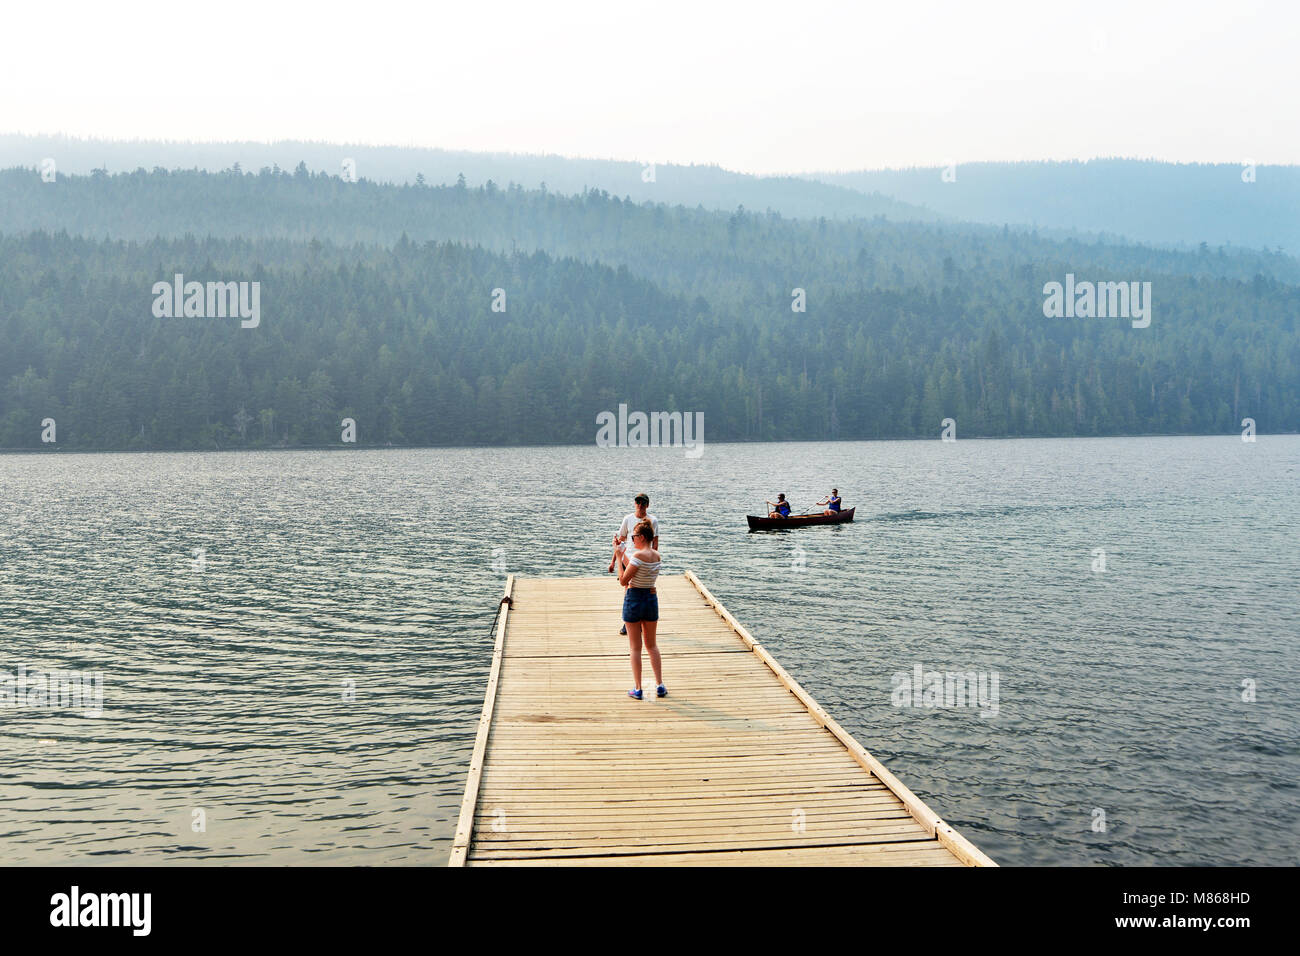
449,571,995,866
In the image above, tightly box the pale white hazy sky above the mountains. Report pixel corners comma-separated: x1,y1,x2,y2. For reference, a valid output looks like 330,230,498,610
0,0,1300,173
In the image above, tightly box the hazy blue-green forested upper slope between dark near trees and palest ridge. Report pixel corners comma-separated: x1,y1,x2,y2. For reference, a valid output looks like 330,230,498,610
0,165,1300,293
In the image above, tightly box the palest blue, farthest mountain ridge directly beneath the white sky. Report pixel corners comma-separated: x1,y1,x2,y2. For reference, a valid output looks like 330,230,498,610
10,134,1300,256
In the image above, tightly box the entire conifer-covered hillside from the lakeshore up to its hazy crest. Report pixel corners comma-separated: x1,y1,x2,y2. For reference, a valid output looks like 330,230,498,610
0,169,1300,449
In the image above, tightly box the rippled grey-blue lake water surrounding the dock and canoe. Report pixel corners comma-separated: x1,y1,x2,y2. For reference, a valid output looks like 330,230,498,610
0,436,1300,865
